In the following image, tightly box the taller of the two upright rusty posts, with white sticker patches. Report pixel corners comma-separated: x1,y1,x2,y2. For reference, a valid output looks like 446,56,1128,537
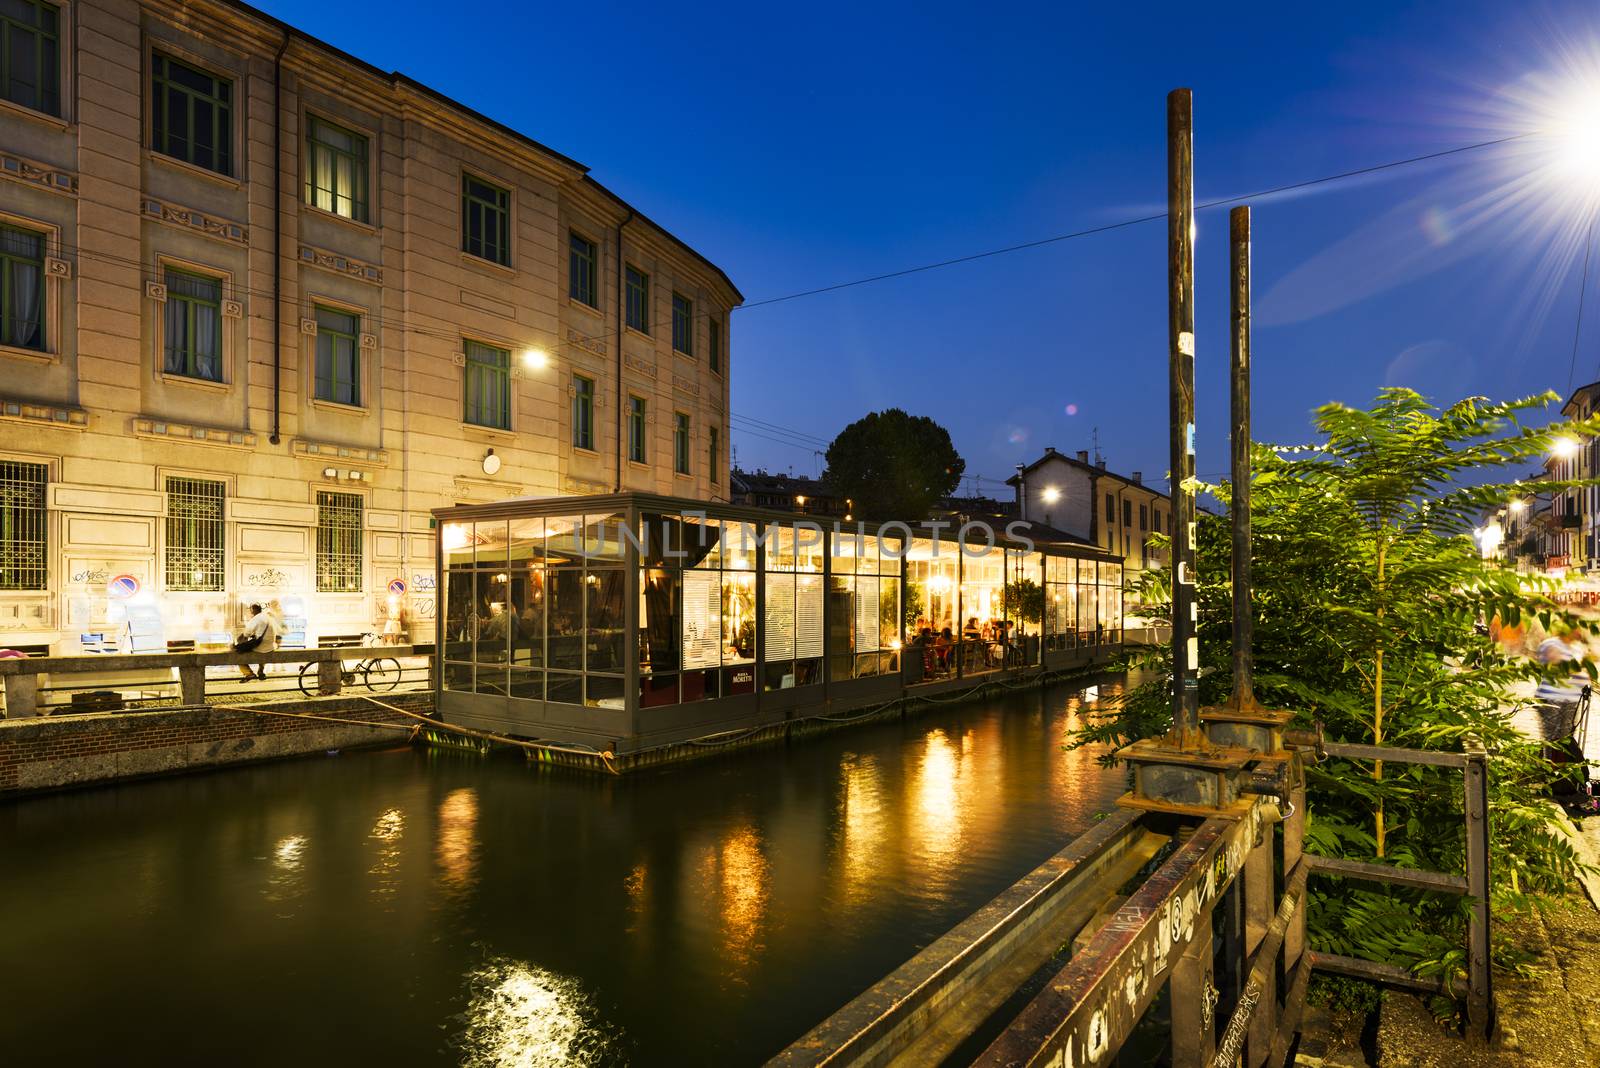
1166,90,1202,748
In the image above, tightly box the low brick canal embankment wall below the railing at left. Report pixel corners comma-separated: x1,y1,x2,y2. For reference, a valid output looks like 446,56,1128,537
0,692,434,798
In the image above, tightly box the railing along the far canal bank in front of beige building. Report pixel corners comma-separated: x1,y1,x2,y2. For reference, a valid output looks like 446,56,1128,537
0,644,434,719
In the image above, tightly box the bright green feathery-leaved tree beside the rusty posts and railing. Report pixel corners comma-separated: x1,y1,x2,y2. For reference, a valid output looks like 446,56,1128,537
1074,389,1600,974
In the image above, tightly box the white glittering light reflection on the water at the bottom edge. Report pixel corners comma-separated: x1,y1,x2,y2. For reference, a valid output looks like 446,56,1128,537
456,958,618,1068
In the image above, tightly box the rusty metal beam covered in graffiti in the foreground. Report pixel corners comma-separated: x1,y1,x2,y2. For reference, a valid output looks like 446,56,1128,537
976,804,1262,1068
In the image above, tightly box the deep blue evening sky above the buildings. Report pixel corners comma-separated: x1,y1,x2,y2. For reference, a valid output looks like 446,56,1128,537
264,0,1600,491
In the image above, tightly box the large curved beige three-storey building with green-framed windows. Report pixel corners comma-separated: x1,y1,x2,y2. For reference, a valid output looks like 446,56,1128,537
0,0,741,652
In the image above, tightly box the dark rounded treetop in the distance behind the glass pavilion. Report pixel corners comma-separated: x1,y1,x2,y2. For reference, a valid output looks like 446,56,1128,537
822,408,966,521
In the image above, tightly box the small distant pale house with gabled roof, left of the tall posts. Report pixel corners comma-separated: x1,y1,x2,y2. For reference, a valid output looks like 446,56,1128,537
1006,448,1173,571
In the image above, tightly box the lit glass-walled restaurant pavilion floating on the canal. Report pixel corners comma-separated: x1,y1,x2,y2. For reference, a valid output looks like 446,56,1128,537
434,494,1123,753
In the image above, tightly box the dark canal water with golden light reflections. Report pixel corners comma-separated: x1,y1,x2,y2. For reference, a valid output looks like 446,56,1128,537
0,686,1122,1065
